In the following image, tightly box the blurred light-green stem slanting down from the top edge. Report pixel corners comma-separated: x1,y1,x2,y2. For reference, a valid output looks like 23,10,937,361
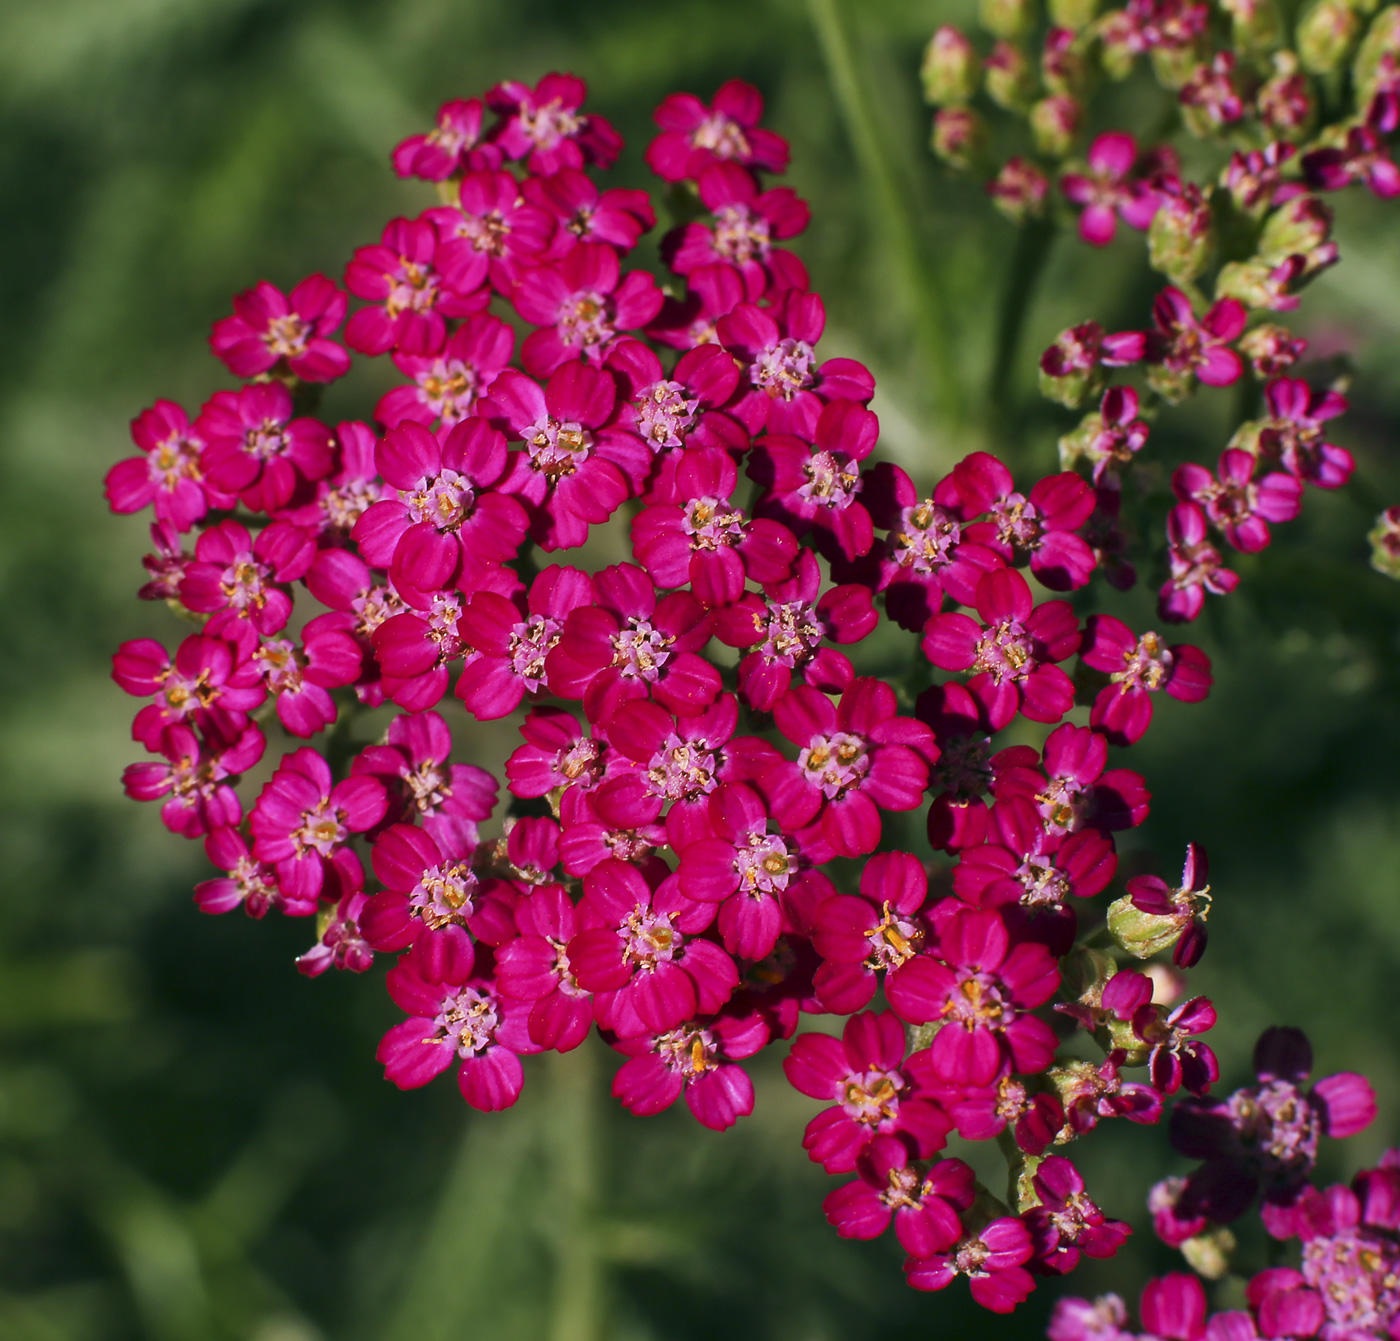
806,0,962,427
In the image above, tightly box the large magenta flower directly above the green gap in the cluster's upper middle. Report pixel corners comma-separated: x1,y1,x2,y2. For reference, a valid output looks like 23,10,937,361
490,363,650,550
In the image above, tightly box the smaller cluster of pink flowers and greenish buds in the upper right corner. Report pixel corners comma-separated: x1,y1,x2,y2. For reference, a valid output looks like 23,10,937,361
923,0,1400,622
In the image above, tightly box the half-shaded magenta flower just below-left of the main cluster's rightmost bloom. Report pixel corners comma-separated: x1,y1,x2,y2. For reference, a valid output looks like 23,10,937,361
991,722,1151,834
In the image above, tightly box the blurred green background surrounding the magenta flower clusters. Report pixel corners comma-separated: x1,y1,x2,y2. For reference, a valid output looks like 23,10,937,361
0,0,1400,1341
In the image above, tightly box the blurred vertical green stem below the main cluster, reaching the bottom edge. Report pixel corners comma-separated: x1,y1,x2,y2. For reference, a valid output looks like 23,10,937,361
549,1036,606,1341
